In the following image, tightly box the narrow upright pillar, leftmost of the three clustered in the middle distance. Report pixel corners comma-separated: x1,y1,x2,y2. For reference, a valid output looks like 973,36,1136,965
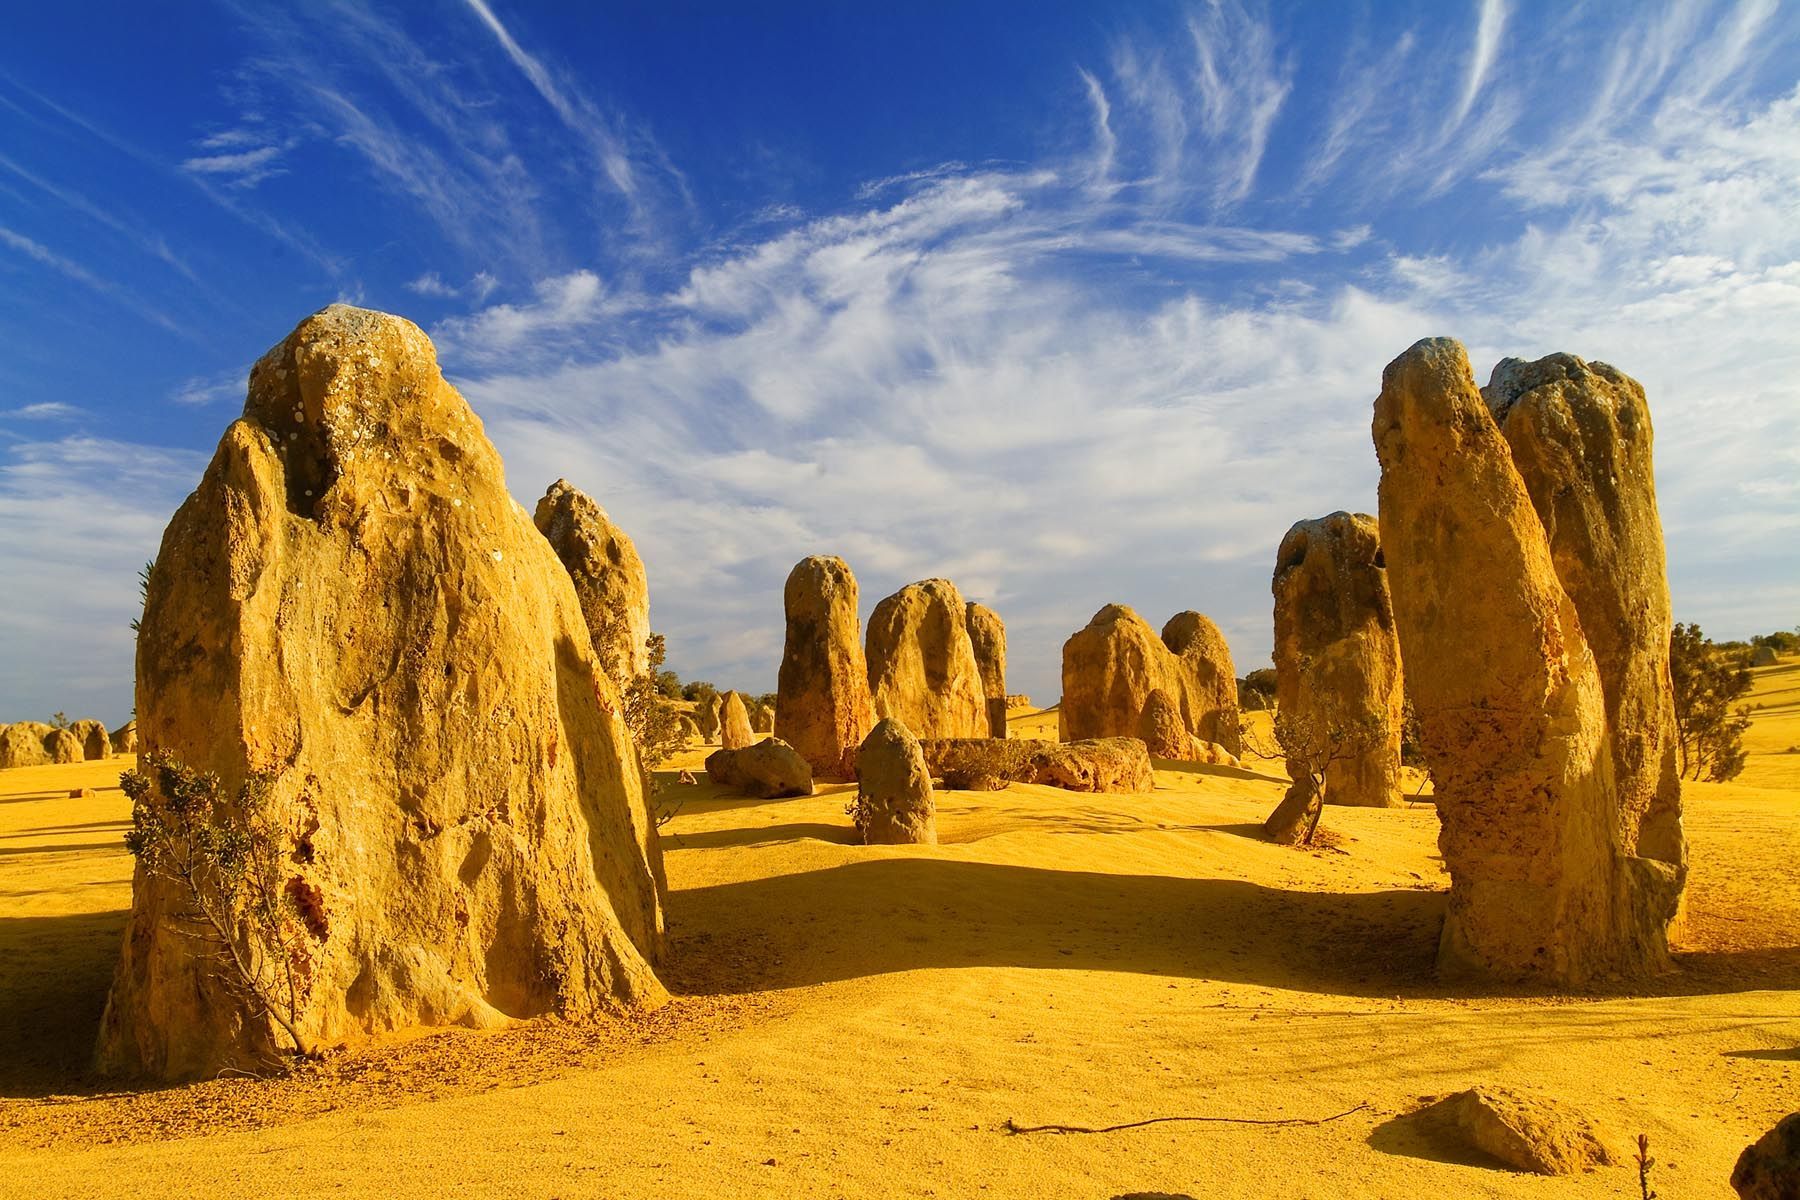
776,554,875,779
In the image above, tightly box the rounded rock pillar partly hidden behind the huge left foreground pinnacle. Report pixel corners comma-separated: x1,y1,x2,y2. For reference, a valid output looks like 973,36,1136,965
531,479,650,689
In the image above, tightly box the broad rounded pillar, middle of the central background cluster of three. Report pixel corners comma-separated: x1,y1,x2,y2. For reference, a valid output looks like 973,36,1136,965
866,579,988,738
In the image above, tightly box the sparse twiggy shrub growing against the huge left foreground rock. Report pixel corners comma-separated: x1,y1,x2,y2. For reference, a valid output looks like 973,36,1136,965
119,752,329,1056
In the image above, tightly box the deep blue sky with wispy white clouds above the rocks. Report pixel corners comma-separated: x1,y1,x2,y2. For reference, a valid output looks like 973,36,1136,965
0,0,1800,721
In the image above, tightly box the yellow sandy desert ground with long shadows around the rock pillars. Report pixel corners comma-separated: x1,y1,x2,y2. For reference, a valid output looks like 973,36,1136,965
0,658,1800,1200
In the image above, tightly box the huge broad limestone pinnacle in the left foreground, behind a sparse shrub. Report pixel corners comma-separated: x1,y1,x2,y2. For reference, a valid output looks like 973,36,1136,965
97,306,664,1079
